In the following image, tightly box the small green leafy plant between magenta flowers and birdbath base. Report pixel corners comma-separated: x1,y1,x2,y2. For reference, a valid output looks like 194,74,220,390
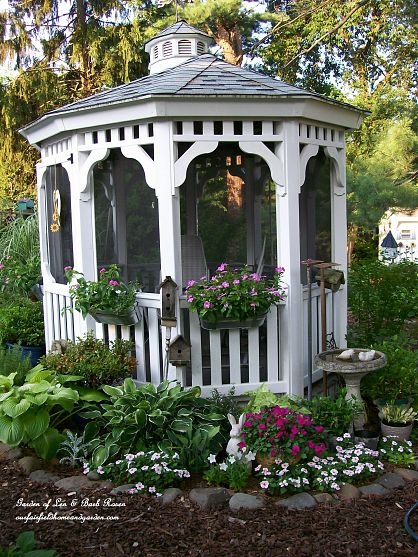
305,388,363,435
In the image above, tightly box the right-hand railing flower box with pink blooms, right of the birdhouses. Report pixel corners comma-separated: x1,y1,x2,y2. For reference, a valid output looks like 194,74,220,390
186,263,285,330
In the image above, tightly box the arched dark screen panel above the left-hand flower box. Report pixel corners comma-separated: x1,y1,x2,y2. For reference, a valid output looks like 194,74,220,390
93,149,160,292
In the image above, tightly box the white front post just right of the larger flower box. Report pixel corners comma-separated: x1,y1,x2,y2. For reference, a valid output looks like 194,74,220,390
276,122,307,395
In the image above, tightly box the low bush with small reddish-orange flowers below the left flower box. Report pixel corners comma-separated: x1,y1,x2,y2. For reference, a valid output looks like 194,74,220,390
41,333,136,388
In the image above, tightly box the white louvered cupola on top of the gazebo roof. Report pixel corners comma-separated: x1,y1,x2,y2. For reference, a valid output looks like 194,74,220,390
145,21,214,74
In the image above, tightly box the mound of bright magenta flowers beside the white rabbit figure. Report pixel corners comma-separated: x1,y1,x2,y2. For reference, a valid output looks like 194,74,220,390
240,406,327,461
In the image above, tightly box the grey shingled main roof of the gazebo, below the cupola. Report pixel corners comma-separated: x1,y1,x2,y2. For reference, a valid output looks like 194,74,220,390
41,54,363,116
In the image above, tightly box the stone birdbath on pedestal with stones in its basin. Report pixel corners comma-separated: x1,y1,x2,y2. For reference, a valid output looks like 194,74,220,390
314,348,387,400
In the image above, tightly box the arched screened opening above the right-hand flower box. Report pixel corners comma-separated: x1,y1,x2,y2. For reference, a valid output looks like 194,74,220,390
180,143,277,286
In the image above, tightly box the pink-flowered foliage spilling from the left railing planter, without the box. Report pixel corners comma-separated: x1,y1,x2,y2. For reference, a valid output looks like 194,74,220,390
65,265,138,317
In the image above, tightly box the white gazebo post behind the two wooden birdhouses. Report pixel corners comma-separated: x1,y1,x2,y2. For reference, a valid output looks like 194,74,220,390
154,122,181,380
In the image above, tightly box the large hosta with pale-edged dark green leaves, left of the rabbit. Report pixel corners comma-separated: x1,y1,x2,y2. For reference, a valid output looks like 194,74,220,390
82,379,226,471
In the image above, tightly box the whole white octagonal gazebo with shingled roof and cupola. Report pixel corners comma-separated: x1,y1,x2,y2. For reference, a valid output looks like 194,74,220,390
21,22,364,394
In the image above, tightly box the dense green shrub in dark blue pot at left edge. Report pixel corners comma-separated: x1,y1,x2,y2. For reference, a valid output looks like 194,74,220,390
0,296,45,366
